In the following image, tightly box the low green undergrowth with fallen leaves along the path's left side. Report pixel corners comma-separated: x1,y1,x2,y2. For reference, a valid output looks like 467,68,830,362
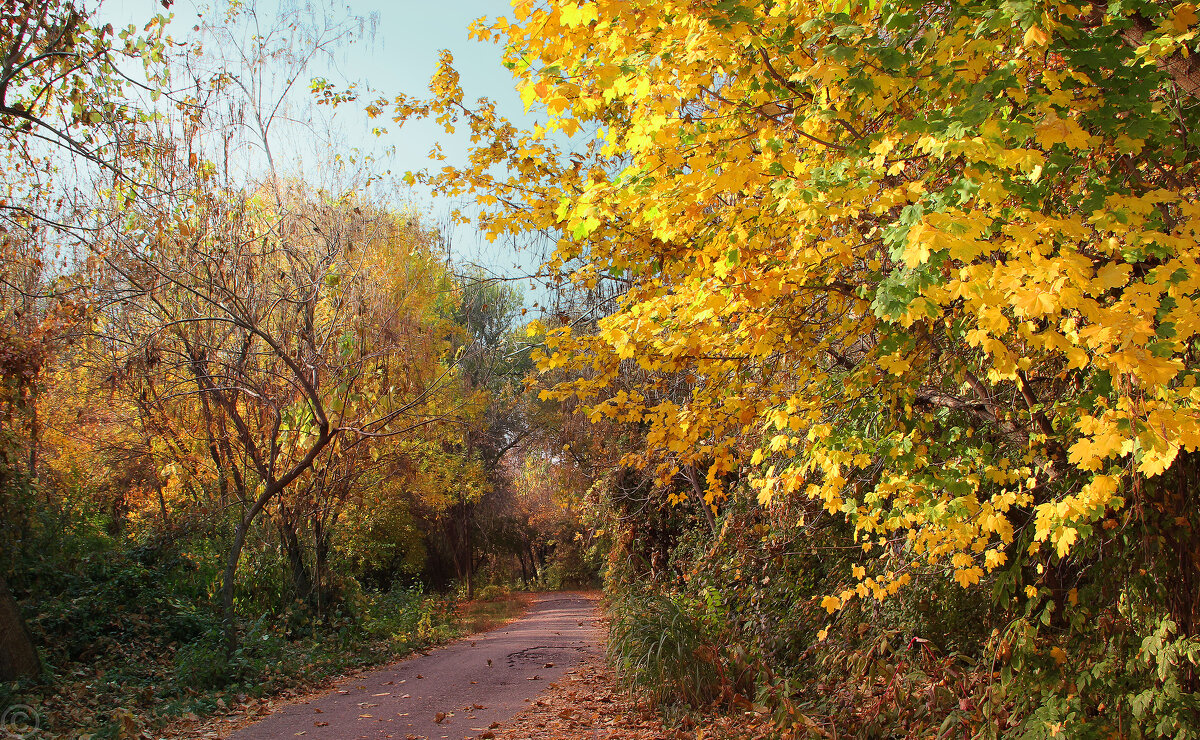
0,531,496,740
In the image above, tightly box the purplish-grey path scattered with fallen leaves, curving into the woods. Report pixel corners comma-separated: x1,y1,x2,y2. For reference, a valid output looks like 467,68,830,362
229,594,604,740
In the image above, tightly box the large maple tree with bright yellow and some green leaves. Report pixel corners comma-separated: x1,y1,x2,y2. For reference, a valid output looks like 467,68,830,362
372,0,1200,729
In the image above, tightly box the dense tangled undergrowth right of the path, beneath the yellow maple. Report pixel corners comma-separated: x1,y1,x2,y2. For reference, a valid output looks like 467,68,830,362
606,484,1200,740
